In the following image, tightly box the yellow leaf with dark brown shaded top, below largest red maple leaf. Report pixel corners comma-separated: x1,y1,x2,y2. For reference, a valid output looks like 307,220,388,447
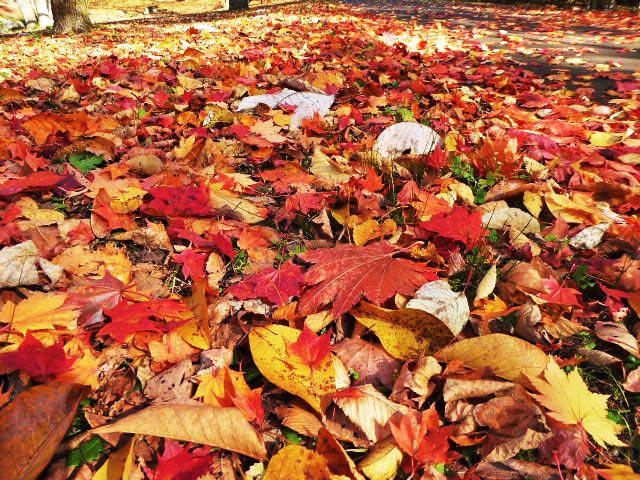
351,302,453,360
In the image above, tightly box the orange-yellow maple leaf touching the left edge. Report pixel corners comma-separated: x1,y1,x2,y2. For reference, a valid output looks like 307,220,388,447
0,292,78,334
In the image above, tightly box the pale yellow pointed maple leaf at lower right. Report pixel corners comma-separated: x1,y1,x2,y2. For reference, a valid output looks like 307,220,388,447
529,360,625,447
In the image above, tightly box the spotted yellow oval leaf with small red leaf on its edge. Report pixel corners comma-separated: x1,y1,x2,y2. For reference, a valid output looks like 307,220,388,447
249,325,336,413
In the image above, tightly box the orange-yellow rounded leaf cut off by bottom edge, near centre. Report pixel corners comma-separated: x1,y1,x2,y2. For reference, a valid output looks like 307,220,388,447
263,445,331,480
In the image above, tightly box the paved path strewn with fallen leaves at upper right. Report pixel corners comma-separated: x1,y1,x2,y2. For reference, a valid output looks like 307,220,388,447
343,0,640,102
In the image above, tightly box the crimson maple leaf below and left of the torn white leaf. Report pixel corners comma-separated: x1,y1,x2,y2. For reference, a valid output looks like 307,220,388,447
140,185,213,217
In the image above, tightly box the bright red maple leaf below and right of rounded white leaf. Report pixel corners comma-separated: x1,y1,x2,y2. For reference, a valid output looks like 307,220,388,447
419,206,487,247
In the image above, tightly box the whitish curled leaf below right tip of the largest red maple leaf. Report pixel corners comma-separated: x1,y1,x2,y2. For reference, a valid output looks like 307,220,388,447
407,280,469,335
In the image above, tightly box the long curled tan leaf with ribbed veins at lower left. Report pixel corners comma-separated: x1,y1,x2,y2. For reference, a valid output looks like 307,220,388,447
92,404,267,460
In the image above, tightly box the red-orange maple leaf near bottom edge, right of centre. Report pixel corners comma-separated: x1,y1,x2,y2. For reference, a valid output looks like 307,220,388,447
389,405,460,465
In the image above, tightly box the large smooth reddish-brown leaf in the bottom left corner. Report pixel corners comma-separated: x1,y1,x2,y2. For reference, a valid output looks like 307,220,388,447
0,382,85,480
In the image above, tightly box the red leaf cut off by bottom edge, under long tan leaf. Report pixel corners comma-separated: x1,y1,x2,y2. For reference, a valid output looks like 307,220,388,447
144,439,214,480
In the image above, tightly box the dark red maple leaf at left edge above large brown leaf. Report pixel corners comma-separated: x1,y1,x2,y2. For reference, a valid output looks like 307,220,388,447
0,332,76,382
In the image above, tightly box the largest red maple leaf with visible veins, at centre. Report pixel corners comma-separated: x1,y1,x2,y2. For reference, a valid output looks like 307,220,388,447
298,242,438,317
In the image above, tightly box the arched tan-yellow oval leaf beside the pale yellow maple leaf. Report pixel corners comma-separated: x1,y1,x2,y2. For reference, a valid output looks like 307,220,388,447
433,333,549,383
